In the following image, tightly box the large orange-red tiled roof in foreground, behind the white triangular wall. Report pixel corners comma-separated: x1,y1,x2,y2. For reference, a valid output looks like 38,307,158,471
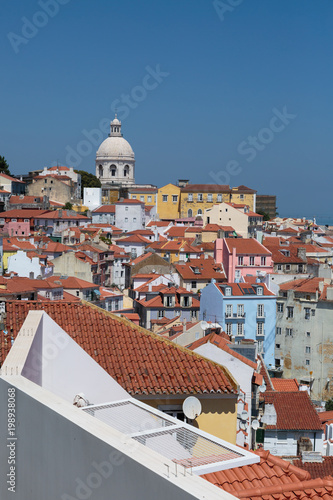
0,301,237,395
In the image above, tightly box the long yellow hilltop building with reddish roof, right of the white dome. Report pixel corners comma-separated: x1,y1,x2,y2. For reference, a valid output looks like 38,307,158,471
180,184,256,218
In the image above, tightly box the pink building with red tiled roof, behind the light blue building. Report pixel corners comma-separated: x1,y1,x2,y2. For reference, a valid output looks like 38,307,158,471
214,238,273,283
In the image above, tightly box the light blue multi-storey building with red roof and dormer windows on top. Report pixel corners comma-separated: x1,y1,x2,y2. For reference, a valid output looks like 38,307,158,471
200,280,276,367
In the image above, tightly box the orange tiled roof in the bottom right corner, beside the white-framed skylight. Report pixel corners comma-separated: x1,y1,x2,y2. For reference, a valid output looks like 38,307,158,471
201,450,333,500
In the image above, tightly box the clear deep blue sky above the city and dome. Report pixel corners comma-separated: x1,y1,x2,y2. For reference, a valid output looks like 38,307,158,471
0,0,333,217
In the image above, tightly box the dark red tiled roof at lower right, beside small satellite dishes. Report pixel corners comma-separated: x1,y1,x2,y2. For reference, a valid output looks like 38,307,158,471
263,391,322,431
